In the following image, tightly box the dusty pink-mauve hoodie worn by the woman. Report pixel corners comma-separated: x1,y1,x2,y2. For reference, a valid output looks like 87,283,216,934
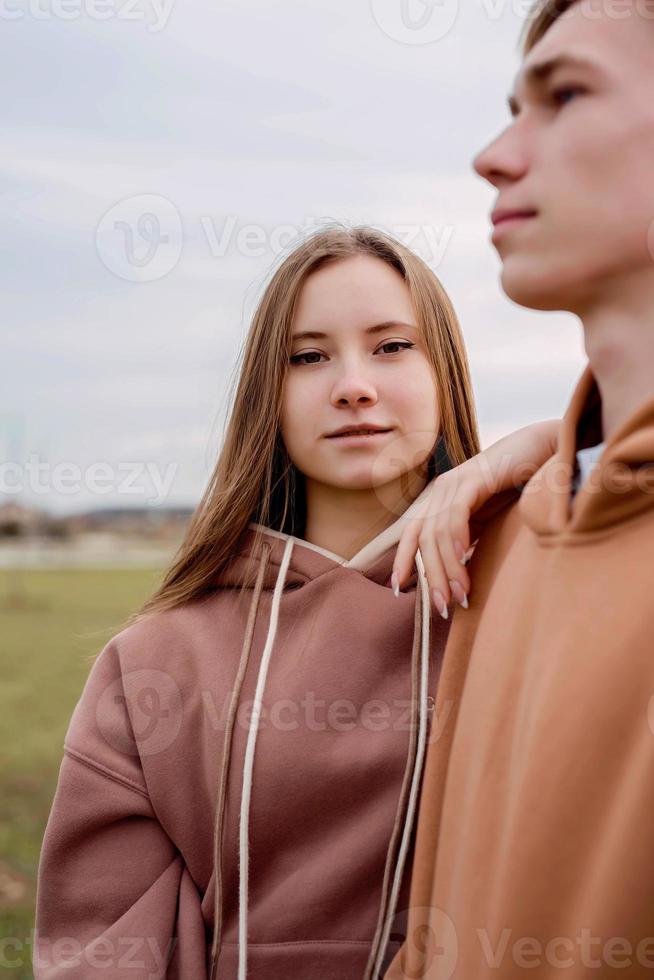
33,504,448,980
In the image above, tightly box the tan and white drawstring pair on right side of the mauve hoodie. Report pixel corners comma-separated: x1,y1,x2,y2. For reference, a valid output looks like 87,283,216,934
364,550,431,980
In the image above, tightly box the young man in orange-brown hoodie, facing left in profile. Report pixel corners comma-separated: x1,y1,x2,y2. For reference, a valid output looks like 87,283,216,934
386,0,654,980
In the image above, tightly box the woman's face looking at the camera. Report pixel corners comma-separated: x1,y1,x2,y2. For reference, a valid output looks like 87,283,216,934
281,255,439,498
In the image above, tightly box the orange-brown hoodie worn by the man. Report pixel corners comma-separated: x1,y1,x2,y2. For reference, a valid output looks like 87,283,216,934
386,368,654,980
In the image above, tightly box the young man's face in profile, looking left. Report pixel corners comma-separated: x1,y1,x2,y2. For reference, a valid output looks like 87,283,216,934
475,0,654,313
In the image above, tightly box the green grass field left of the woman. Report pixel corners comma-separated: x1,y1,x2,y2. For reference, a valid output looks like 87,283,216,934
0,569,167,980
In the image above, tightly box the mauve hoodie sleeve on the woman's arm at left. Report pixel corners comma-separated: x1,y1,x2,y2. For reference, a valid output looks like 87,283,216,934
33,639,207,980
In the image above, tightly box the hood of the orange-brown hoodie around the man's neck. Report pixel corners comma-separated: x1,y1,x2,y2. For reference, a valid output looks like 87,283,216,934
519,366,654,539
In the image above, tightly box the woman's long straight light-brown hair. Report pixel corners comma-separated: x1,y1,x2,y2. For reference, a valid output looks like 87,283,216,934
127,226,479,625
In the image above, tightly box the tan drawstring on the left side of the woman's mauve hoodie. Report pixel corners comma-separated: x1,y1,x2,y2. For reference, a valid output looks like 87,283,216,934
209,542,272,980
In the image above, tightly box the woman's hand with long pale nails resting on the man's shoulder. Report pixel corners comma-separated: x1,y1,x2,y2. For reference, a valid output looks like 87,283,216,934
391,419,560,619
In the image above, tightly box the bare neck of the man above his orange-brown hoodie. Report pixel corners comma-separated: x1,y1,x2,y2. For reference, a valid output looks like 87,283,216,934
582,291,654,442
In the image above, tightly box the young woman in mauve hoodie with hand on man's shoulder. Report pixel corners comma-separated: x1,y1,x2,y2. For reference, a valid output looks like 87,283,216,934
34,228,553,980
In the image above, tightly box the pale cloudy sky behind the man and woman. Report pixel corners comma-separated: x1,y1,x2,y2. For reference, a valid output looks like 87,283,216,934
0,0,584,513
